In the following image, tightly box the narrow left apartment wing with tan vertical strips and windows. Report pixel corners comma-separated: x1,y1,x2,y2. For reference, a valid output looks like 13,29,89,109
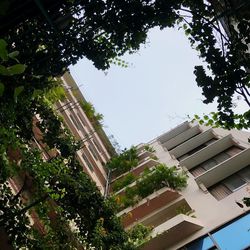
56,72,115,194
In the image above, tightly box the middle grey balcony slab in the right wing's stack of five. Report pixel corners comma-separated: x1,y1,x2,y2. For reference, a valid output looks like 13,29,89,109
169,129,214,158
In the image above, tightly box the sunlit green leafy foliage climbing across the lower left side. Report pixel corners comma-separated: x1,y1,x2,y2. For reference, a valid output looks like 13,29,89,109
0,40,131,249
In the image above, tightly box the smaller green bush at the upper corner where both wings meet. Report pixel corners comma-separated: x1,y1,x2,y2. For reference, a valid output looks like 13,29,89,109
106,147,139,175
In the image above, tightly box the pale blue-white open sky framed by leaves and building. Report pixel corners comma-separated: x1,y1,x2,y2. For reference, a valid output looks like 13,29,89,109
70,28,221,149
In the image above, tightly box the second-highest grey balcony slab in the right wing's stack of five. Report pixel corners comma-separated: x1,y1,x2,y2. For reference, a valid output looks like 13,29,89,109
162,125,201,150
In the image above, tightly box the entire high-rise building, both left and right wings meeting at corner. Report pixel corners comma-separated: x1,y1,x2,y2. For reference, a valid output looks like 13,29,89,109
25,73,250,250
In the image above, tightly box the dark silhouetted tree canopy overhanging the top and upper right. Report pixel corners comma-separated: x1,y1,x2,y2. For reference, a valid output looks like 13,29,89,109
0,0,250,126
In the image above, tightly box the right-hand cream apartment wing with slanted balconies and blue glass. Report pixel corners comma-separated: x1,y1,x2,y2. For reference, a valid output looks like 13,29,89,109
111,122,250,250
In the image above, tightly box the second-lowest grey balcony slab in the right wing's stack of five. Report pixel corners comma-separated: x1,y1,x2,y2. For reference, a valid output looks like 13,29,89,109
180,135,234,170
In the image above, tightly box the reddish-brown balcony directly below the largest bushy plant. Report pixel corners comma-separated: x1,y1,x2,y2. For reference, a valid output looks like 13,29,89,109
118,187,181,228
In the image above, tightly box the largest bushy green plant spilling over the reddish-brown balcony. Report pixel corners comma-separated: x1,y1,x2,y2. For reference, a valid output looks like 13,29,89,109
115,164,187,211
